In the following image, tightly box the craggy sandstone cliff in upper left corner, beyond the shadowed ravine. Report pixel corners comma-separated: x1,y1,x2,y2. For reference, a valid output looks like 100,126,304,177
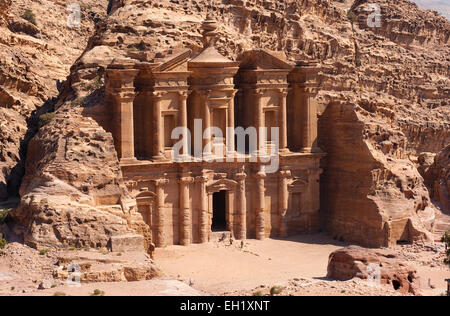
0,0,106,201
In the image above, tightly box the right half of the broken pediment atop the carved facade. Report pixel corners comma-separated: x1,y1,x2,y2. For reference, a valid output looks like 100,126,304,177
238,49,293,71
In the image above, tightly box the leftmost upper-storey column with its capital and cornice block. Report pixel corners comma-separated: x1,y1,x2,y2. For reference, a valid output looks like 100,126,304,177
106,65,139,162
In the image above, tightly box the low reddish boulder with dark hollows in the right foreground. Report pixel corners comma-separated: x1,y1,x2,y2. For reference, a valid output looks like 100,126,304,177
327,246,419,294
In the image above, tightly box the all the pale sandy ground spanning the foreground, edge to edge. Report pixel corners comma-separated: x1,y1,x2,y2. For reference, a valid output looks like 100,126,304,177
0,234,450,296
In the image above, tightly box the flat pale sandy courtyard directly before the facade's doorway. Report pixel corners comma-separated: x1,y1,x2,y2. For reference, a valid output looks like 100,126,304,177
154,234,346,295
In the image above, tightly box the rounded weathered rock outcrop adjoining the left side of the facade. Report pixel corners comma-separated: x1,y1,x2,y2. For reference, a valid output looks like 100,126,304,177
11,110,151,250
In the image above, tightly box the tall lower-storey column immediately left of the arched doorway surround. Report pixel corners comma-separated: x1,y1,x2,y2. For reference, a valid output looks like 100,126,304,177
179,172,193,246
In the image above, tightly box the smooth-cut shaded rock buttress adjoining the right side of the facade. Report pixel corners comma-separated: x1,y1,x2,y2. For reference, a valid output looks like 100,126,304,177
319,101,434,247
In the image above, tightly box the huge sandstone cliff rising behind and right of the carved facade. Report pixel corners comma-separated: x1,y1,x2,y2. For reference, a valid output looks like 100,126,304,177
3,0,450,247
